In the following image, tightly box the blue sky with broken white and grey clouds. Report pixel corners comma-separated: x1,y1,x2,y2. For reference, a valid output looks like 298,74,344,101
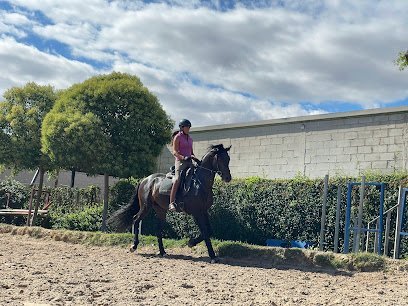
0,0,408,127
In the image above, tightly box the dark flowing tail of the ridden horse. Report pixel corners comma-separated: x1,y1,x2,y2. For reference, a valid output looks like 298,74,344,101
107,184,140,232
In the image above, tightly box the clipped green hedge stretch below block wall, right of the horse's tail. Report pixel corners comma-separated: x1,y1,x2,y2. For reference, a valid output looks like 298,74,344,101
135,174,408,254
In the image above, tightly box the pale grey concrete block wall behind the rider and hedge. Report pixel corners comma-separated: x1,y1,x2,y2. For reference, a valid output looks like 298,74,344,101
158,107,408,178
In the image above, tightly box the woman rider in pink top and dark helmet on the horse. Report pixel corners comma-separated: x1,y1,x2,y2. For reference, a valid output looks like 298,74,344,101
169,119,195,211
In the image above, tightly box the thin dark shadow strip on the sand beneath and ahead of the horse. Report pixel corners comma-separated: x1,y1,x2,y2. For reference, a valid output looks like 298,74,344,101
138,253,354,277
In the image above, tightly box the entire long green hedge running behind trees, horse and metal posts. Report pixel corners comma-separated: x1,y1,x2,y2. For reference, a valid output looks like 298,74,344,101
0,173,408,254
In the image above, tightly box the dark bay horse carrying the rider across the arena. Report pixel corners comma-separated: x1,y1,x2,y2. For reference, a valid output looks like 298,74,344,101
108,144,232,263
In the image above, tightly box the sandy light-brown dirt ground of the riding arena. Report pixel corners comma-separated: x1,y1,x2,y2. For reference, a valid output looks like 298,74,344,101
0,234,408,306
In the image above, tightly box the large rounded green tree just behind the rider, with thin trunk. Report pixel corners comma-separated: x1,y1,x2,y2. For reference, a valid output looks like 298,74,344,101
42,72,173,229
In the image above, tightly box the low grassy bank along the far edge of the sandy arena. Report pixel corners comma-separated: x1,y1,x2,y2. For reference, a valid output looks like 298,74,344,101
0,224,408,272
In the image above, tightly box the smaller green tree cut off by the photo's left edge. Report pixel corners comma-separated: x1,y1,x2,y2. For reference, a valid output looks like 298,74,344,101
0,82,57,224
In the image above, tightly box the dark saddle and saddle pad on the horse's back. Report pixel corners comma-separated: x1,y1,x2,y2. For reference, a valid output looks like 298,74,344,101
159,166,201,203
